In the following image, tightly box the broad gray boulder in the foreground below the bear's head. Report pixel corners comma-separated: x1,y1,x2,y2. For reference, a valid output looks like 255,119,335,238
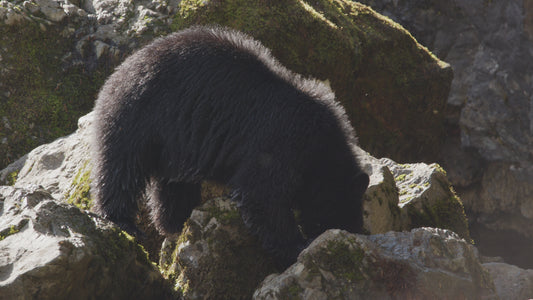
254,228,497,299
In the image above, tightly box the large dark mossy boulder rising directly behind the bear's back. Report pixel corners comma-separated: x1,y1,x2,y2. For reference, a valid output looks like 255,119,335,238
172,0,453,161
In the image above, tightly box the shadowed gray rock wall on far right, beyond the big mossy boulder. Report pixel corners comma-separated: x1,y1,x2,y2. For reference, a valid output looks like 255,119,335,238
361,0,533,268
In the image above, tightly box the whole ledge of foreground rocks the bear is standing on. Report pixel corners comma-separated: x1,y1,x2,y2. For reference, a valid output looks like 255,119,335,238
0,114,533,299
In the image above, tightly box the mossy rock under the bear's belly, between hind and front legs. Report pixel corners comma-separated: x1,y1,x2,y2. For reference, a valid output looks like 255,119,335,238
160,198,276,299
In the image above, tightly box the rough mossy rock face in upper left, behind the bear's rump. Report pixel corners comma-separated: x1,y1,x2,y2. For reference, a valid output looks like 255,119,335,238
0,0,178,168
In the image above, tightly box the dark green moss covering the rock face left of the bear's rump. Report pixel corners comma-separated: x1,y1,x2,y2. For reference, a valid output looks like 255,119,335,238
0,21,112,169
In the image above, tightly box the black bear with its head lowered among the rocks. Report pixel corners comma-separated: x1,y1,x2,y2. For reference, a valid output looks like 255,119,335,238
89,26,369,263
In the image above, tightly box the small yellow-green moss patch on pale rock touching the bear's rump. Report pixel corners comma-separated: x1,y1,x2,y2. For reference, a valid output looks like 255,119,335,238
65,161,92,210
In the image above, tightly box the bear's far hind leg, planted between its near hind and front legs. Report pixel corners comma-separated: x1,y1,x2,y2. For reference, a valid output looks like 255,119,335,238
148,179,201,235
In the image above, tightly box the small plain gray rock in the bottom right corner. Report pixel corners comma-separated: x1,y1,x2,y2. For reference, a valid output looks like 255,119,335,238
483,263,533,300
